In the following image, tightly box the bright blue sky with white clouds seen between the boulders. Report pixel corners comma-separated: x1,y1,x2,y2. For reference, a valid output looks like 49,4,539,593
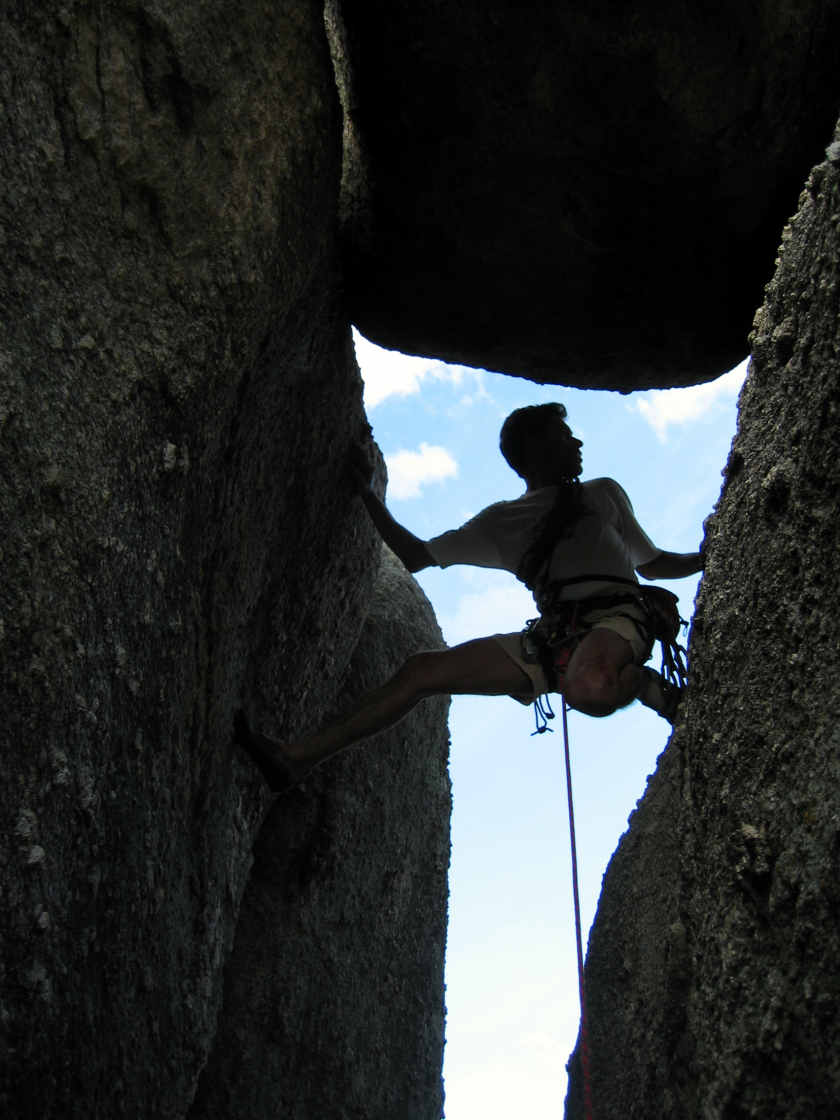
355,335,746,1120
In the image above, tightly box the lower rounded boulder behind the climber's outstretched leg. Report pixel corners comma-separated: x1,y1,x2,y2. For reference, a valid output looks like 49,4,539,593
189,549,450,1120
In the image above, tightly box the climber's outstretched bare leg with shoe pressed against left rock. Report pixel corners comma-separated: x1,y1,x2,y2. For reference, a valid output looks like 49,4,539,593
261,637,532,773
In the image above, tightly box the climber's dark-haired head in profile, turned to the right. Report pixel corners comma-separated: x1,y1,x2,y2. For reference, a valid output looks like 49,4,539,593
498,401,584,489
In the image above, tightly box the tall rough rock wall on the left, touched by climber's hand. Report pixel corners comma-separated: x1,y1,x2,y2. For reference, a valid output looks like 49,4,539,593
0,0,377,1120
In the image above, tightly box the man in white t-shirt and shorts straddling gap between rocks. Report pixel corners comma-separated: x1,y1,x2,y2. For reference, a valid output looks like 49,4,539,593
234,403,703,790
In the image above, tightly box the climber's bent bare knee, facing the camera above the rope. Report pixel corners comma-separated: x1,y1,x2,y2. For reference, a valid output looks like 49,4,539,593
564,626,642,716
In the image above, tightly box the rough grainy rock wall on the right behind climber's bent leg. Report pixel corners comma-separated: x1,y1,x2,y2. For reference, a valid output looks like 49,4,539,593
567,122,840,1120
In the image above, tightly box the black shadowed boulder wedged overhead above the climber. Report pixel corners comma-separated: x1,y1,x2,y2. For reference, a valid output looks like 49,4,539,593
340,0,840,390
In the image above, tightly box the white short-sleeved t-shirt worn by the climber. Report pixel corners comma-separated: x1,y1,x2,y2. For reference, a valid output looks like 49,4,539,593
426,478,662,599
